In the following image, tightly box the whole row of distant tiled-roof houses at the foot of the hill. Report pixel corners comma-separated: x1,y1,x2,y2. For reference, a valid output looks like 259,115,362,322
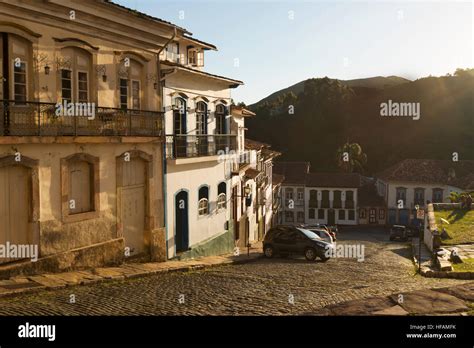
274,159,474,225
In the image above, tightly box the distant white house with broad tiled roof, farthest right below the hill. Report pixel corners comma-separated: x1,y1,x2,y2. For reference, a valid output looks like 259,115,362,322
376,159,474,225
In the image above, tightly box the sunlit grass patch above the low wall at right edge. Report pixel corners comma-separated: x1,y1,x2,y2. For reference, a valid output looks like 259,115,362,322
435,209,474,245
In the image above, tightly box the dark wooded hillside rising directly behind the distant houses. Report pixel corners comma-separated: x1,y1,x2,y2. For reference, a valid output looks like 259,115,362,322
247,71,474,174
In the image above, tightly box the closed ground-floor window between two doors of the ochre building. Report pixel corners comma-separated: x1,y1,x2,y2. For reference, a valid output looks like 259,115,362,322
61,153,100,222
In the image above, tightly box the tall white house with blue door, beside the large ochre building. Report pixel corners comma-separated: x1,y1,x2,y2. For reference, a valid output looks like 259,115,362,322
160,33,243,258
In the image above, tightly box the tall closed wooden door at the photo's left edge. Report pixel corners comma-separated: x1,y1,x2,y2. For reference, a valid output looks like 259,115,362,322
0,166,33,263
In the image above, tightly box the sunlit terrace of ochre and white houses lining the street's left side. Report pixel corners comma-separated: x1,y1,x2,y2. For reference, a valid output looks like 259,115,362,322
0,0,281,273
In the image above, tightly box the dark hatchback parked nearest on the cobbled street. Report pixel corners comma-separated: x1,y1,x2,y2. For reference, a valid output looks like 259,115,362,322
263,226,333,262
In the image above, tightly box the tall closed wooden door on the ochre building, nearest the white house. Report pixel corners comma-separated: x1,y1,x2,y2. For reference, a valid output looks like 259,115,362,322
118,158,147,256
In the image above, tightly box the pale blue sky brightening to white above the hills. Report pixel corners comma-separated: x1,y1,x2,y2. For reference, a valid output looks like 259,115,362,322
114,0,474,105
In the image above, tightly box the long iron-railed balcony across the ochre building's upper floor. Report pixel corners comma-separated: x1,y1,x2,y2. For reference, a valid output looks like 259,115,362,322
0,100,164,137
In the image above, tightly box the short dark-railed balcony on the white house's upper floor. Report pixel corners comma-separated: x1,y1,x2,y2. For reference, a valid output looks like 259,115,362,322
166,134,237,160
